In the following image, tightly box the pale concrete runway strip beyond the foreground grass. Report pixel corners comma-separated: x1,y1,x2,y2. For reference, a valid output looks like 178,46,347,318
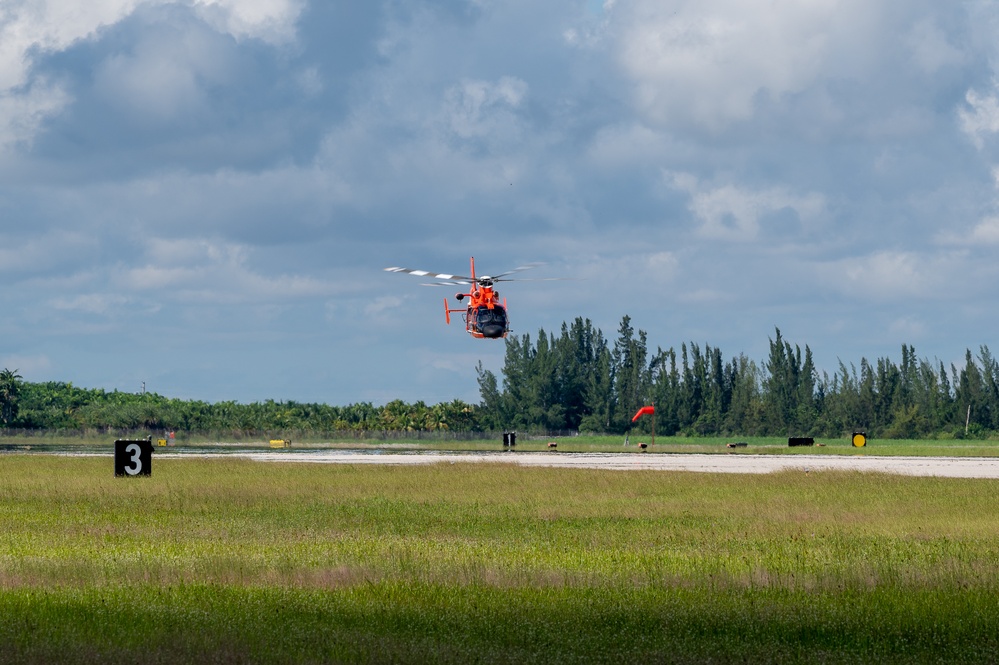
172,450,999,478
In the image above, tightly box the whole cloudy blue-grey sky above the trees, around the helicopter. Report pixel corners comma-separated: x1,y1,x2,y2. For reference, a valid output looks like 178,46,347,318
0,0,999,405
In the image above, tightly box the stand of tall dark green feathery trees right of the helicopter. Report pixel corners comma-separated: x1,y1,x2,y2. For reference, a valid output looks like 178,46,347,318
478,316,999,438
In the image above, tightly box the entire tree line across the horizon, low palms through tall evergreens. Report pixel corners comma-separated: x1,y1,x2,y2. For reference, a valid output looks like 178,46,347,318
0,316,999,438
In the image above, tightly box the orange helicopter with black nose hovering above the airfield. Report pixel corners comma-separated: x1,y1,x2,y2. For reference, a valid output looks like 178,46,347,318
385,256,557,339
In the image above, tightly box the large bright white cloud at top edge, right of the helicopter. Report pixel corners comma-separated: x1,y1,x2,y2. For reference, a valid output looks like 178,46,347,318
614,0,884,131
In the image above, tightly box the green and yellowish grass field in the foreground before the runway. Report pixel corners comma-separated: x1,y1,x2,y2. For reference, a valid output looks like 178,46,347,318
0,455,999,663
